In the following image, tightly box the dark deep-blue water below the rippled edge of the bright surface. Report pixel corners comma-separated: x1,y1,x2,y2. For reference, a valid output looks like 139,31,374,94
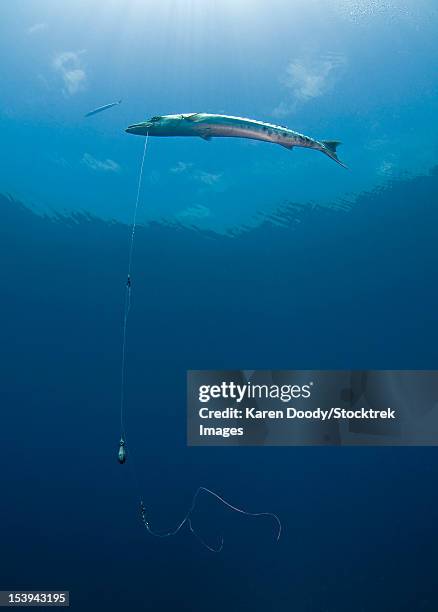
0,170,438,612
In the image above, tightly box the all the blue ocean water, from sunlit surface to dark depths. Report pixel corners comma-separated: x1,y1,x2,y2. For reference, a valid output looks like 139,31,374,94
0,0,438,612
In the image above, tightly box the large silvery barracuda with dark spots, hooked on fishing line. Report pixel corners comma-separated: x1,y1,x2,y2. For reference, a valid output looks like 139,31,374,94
126,113,347,168
